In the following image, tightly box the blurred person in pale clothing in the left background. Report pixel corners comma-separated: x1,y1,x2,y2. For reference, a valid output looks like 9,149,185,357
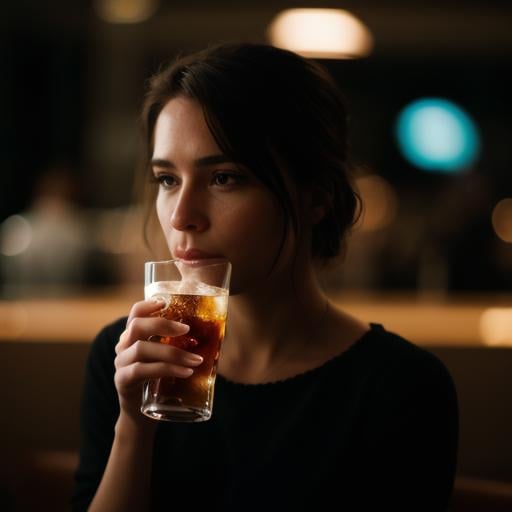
0,162,117,296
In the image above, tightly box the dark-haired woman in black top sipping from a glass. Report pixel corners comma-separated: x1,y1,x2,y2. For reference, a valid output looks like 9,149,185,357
74,44,457,511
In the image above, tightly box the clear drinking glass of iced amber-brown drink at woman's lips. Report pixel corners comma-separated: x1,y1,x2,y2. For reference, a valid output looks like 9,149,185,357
141,260,231,422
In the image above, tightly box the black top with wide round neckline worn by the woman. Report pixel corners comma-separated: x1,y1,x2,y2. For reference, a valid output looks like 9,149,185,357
73,318,458,512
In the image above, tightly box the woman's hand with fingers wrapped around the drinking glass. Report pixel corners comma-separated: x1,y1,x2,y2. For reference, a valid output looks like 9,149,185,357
114,300,203,426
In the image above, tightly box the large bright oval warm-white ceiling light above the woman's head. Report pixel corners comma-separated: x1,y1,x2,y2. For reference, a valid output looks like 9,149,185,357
269,9,373,59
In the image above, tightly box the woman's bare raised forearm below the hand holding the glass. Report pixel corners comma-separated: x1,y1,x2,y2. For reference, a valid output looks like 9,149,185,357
89,413,155,512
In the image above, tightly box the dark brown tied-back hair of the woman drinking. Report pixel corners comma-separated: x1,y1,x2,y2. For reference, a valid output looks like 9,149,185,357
142,43,360,261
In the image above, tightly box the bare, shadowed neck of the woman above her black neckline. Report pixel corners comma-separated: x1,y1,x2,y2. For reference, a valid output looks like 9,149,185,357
219,270,334,381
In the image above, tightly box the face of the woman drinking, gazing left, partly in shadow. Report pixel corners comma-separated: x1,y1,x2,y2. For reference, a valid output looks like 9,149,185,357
152,97,291,294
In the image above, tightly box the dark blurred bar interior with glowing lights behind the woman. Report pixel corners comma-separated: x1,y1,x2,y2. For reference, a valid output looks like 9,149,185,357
0,0,512,510
